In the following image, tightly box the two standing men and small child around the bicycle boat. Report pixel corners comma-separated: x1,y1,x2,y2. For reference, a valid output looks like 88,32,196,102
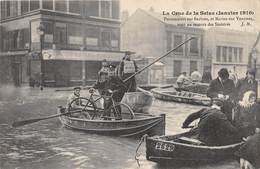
67,51,137,120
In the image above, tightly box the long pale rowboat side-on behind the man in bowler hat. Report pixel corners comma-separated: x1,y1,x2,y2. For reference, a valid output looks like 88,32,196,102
151,87,211,106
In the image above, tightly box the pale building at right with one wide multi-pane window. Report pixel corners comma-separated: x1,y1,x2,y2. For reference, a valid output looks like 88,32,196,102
204,28,260,78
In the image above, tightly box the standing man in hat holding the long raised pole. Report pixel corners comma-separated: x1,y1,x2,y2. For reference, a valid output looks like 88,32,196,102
117,51,138,92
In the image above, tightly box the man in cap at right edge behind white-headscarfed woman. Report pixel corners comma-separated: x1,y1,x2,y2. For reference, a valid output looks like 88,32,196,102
237,69,258,100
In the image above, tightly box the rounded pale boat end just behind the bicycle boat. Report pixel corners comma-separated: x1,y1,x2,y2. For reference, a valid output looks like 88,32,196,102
121,87,153,113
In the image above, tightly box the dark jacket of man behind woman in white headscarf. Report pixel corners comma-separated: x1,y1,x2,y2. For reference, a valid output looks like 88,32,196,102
237,77,258,100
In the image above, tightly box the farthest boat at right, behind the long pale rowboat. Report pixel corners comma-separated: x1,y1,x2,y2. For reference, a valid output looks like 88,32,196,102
175,82,209,94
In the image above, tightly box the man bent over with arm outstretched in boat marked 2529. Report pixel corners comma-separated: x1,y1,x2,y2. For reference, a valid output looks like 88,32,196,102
182,99,241,146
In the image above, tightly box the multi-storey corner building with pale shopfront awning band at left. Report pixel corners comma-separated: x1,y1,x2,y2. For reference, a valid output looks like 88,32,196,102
0,0,124,86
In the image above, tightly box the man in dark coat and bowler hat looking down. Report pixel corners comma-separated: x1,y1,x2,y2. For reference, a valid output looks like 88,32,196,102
207,68,236,120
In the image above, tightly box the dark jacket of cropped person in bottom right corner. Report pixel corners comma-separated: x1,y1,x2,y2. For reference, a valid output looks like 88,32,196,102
236,133,260,168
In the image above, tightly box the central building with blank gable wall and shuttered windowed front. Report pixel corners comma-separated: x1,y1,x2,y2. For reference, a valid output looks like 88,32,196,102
121,9,204,82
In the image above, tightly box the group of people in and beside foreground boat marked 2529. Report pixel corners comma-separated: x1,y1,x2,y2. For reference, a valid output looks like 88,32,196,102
182,68,260,169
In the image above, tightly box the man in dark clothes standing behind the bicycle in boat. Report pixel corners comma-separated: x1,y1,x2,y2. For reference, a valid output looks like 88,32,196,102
93,65,127,120
